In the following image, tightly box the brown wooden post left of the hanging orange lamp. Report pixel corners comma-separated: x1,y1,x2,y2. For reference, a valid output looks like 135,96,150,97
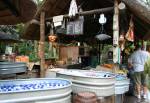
39,12,45,78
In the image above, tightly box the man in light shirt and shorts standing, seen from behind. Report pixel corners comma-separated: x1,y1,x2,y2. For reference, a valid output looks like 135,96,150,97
129,45,149,99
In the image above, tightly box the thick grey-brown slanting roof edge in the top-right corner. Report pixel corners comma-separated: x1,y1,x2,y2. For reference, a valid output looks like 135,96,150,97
122,0,150,24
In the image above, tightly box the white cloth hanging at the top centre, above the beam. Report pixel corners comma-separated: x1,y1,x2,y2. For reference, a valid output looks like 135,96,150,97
69,0,78,17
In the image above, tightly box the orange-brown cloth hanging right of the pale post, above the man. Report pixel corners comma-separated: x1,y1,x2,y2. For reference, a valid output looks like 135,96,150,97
125,17,134,42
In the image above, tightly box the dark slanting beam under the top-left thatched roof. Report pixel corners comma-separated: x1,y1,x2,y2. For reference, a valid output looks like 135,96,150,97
2,0,19,16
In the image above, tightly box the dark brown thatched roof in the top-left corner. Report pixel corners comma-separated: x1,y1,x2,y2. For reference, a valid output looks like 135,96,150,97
0,0,37,25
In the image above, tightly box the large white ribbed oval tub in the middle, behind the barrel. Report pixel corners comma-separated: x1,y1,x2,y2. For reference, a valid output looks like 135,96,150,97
56,69,115,97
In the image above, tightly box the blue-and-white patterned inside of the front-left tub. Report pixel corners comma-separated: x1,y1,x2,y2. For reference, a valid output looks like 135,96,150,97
0,79,71,93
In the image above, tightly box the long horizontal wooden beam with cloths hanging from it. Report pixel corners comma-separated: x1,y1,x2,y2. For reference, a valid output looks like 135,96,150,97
46,7,114,21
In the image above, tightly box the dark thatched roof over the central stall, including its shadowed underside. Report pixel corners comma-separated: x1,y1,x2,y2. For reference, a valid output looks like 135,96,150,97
22,0,150,40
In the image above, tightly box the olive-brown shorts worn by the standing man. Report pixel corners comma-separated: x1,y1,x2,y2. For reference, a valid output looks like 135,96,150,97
133,72,146,86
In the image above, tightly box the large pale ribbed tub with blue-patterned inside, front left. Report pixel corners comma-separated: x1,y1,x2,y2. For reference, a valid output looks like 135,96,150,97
0,78,71,103
